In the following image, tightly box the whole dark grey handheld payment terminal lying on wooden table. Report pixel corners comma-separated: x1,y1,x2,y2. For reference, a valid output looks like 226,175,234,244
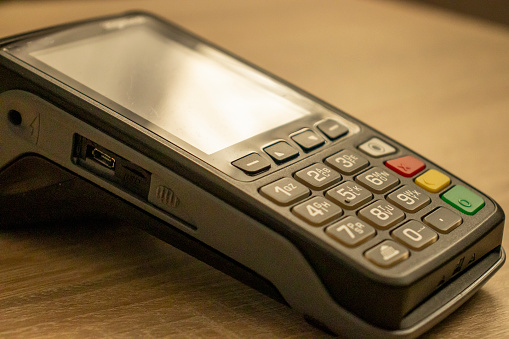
0,12,505,338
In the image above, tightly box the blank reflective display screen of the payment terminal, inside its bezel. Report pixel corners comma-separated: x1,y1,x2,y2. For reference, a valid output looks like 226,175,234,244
30,25,310,154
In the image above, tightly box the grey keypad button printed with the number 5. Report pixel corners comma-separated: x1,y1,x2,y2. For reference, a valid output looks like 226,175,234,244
325,181,373,210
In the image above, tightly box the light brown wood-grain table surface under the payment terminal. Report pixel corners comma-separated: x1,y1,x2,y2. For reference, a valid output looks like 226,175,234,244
0,0,509,338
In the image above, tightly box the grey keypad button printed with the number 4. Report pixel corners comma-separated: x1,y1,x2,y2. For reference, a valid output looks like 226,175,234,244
292,197,343,226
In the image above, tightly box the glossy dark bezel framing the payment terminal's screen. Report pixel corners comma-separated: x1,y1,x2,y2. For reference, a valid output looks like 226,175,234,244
3,13,359,181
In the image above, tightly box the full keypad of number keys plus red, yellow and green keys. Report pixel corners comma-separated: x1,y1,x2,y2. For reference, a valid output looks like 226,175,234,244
259,138,484,269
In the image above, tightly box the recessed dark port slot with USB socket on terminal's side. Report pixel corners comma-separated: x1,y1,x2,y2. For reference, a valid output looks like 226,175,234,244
72,134,152,200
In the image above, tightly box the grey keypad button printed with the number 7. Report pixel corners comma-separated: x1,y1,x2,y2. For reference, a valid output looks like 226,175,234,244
325,217,376,247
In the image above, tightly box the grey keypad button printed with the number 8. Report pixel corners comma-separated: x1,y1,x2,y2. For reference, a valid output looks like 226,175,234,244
359,200,405,229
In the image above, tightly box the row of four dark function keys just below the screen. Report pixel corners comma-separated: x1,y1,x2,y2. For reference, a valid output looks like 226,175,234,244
232,119,348,175
